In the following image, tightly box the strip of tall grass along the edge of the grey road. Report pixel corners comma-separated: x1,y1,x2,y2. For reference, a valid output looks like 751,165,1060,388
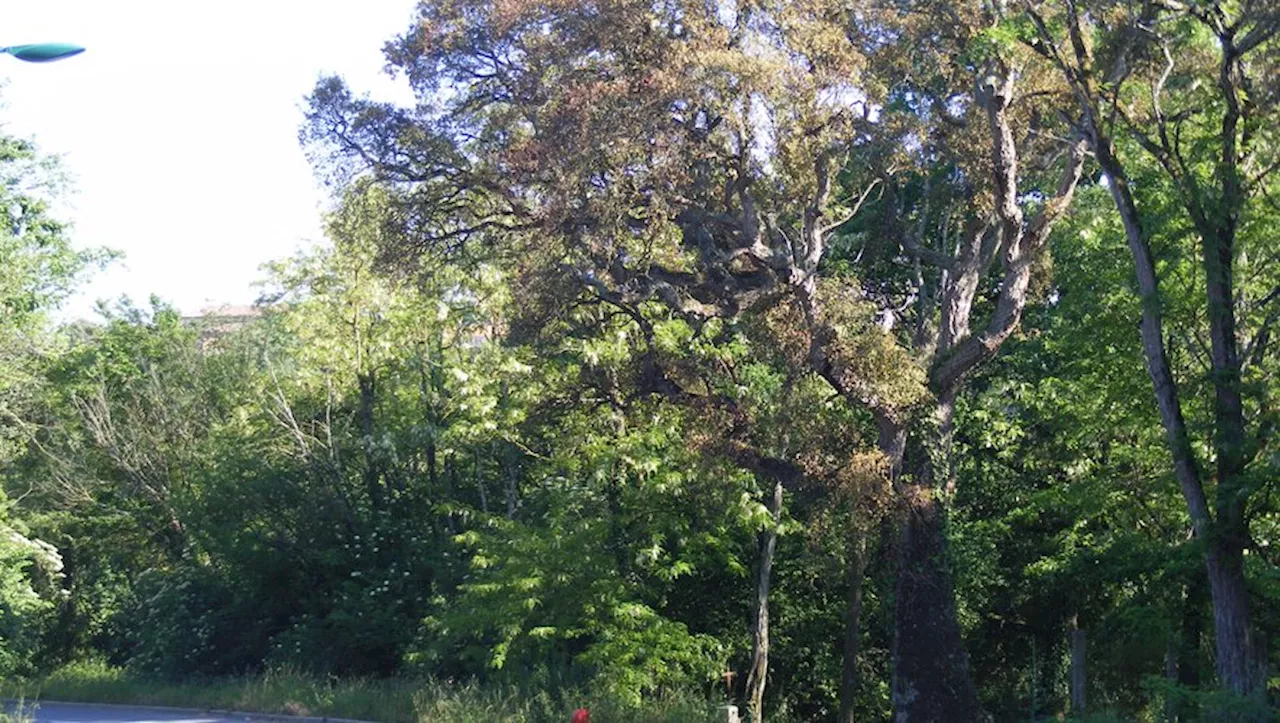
0,663,723,723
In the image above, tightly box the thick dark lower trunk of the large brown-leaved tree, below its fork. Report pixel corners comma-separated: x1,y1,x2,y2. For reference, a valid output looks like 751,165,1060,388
881,399,983,723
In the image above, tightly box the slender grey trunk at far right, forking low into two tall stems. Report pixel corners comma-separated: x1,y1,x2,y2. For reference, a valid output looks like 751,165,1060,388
1029,3,1275,696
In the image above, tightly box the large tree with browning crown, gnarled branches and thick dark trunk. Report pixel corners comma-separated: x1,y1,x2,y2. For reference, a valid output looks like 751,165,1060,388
305,0,1083,720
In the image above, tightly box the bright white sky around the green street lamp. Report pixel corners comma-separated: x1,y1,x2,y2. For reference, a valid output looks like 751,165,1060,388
0,0,416,319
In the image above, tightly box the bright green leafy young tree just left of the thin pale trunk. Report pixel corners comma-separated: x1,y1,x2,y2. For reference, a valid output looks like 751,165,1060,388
416,399,754,700
